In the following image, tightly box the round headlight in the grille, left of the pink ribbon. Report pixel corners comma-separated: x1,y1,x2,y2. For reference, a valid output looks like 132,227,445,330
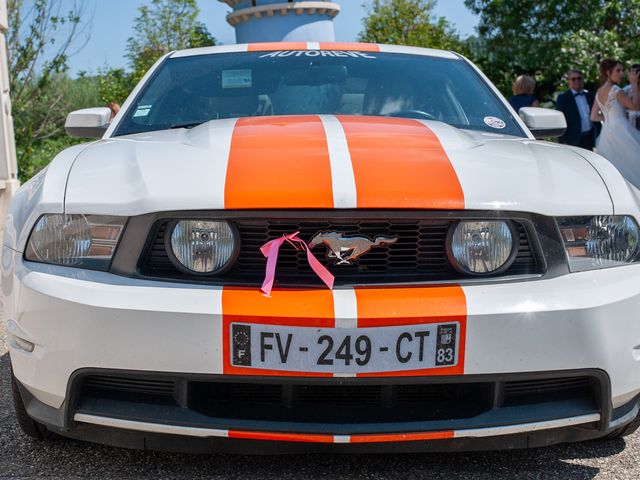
166,220,238,275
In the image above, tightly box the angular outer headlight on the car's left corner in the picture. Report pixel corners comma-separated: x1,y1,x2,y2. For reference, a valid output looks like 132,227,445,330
25,213,127,271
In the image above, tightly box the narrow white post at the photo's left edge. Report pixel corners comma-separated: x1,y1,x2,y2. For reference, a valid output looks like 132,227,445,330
0,0,20,226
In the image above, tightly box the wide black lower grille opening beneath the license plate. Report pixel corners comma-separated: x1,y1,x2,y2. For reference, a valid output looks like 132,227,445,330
74,373,601,424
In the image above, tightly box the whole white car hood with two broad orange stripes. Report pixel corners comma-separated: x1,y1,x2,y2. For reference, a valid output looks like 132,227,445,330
65,115,613,215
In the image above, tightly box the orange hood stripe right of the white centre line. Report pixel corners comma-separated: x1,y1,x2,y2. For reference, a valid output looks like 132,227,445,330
338,116,464,210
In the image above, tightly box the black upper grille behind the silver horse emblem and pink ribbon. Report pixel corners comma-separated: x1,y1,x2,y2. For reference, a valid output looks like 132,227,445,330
138,218,542,286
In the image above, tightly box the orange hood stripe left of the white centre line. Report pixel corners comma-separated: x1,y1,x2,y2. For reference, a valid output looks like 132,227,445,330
225,115,333,208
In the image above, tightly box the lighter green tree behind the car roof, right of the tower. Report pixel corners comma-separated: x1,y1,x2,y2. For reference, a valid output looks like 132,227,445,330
359,0,466,52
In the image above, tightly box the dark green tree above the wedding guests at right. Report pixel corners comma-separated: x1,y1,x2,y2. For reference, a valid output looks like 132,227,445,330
465,0,640,93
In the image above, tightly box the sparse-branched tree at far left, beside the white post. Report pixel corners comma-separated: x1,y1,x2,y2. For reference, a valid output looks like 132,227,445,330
7,0,90,179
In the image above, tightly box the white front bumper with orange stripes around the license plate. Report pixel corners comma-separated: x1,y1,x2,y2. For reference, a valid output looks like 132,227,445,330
3,248,640,449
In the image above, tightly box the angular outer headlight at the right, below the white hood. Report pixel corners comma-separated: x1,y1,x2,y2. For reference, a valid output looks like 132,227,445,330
557,215,640,272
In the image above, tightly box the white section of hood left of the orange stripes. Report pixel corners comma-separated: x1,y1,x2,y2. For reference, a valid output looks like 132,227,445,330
65,119,236,216
